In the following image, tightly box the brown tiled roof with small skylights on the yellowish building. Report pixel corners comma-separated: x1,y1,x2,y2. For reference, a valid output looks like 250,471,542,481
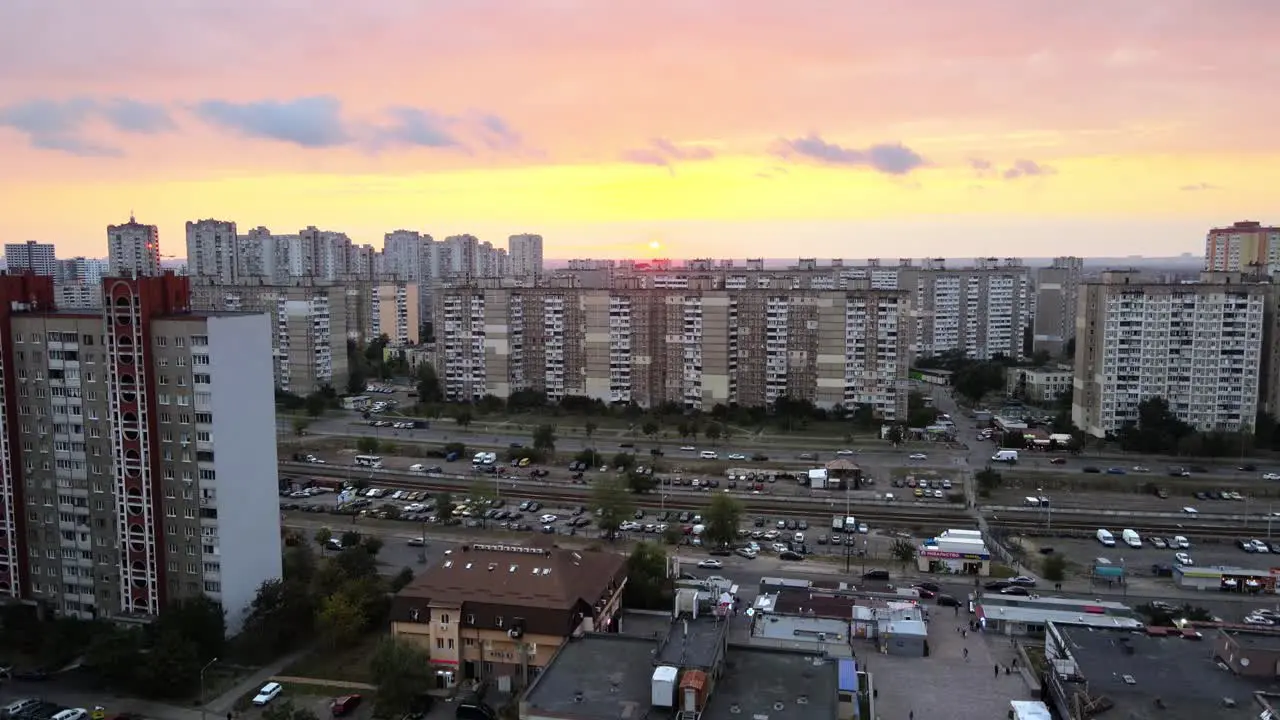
397,543,626,609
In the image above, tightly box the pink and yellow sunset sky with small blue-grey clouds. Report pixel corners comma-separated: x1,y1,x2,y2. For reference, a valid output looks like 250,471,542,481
0,0,1280,259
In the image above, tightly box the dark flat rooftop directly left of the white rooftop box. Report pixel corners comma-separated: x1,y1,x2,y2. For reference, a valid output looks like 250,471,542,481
521,634,657,720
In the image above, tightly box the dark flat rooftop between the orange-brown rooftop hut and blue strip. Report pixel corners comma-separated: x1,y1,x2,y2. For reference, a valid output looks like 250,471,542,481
701,646,838,720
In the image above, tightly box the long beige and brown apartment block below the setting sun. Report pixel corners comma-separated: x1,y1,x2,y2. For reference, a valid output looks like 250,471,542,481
434,278,911,418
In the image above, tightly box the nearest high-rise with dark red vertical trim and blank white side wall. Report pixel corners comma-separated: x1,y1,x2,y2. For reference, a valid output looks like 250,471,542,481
0,275,280,632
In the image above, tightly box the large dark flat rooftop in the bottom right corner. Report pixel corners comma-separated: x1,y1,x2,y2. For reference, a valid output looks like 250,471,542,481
1057,626,1276,720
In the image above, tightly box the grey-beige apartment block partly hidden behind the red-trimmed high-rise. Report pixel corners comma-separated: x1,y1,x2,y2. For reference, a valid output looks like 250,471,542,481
191,281,350,395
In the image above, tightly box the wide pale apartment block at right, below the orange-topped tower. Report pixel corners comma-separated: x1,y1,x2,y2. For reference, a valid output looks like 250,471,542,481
1071,272,1272,437
